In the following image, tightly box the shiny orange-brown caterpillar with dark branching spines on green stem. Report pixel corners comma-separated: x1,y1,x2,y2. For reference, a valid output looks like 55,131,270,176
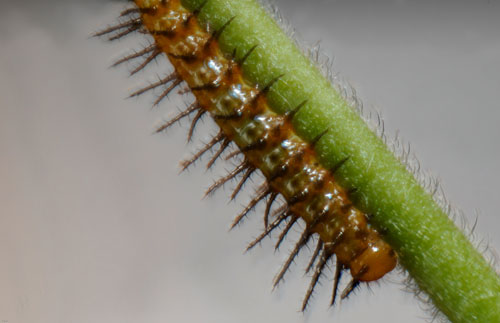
96,0,397,310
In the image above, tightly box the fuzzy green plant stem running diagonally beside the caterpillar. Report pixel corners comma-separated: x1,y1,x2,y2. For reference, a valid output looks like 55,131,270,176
183,0,500,322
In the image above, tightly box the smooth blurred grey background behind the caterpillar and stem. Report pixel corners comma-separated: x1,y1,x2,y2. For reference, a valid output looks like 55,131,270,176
0,0,500,323
